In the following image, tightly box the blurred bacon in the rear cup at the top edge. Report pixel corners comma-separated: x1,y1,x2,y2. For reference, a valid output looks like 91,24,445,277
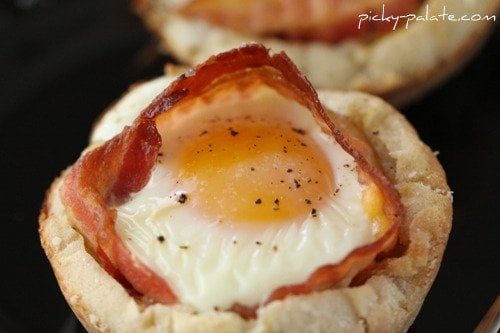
179,0,422,42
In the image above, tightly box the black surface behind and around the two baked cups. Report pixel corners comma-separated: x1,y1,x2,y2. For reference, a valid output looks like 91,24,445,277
0,0,500,333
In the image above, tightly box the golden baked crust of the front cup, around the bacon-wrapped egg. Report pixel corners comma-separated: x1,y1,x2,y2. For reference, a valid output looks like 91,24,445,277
39,72,452,332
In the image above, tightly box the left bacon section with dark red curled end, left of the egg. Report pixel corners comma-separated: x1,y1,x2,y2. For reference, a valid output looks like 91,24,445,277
62,119,176,303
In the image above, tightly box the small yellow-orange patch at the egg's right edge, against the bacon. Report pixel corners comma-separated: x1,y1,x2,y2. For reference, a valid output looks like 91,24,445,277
361,182,390,239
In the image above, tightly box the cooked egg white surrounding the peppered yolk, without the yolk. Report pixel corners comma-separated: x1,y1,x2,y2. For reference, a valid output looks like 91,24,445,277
110,86,375,311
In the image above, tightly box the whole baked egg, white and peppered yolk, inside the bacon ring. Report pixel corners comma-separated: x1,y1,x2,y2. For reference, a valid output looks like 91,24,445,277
113,84,387,311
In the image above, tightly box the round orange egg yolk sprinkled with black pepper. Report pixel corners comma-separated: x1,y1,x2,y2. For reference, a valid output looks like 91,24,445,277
174,120,334,223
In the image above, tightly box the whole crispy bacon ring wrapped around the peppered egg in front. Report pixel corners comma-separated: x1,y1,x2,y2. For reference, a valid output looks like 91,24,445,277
62,44,403,318
